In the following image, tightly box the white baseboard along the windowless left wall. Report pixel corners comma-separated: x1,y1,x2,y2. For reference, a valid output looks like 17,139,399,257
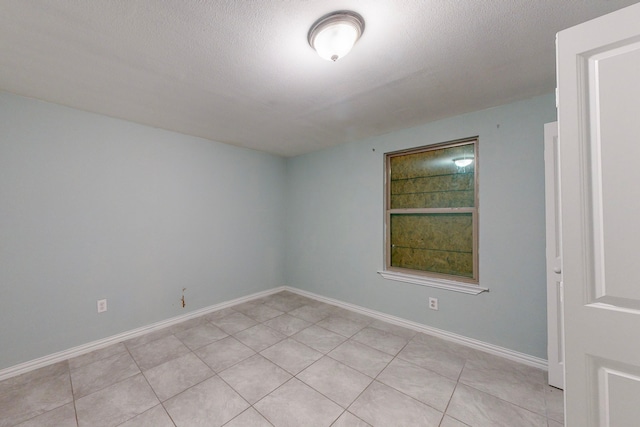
0,286,285,381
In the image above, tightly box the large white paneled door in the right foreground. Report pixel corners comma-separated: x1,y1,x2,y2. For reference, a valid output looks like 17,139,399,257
557,3,640,427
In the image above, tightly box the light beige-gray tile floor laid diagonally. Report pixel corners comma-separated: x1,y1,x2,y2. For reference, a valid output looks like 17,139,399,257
0,292,564,427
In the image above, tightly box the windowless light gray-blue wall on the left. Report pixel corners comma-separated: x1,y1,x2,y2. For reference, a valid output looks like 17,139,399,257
0,93,286,369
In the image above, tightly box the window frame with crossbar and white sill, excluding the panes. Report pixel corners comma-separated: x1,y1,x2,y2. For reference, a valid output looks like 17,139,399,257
379,136,488,294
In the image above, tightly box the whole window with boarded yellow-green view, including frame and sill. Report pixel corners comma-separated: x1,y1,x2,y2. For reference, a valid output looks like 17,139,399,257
380,138,486,293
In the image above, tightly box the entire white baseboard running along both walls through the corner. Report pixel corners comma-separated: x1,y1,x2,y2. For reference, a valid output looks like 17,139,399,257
0,286,548,381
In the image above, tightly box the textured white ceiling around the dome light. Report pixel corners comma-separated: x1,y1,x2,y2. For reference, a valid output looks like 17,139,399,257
0,0,636,156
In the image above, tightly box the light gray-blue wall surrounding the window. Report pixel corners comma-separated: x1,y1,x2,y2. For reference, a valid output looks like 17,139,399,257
286,95,556,359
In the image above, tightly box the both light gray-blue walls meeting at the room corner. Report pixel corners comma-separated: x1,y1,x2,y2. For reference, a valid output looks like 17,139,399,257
0,93,555,369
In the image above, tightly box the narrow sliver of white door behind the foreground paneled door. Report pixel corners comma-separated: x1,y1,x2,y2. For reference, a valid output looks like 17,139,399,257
544,122,564,388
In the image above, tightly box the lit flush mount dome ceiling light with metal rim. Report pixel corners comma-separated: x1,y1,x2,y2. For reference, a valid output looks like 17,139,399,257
307,10,364,62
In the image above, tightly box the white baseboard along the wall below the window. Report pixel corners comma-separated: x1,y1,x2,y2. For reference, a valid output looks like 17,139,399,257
282,286,548,371
